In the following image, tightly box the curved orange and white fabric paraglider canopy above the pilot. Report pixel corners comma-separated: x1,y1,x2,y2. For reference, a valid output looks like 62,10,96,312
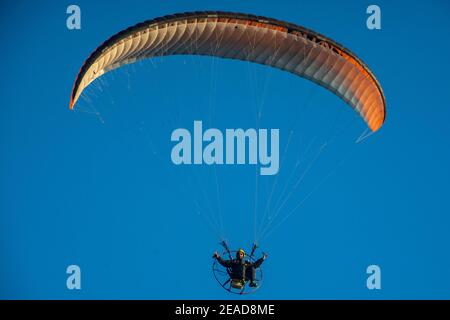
70,12,386,131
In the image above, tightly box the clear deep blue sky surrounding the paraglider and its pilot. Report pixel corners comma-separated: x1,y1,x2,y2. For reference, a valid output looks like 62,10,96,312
0,0,450,299
